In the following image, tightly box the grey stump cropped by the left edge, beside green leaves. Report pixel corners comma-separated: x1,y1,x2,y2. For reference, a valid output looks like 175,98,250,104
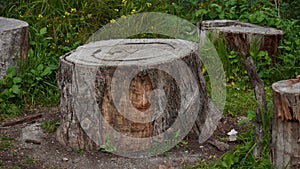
0,17,28,79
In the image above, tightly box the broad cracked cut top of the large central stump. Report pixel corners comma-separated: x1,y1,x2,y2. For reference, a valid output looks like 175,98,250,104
65,39,198,66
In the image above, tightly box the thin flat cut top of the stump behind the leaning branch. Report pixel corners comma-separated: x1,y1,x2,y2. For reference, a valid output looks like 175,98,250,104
201,20,283,35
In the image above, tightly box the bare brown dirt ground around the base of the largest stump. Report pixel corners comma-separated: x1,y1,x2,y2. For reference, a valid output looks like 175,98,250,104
0,108,244,169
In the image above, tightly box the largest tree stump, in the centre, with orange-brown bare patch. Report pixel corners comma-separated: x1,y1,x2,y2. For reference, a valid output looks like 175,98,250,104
57,39,212,155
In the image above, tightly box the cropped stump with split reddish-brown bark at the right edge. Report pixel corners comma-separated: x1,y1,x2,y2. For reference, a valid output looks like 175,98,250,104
271,76,300,168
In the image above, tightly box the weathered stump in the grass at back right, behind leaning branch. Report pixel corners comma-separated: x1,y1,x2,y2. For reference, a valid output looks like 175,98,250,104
199,20,283,63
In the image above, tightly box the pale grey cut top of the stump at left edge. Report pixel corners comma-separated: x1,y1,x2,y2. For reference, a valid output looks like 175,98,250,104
0,17,28,32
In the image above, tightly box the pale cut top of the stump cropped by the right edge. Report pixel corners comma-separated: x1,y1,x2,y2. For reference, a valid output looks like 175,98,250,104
272,75,300,94
